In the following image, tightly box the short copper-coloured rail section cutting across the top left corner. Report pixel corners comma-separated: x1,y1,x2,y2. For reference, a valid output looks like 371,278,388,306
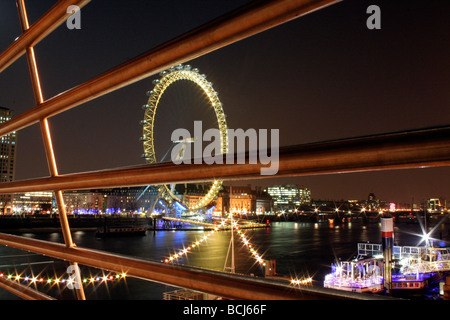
0,0,91,72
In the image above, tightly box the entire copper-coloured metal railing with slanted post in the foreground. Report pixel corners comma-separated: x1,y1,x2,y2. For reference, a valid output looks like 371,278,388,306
0,0,450,299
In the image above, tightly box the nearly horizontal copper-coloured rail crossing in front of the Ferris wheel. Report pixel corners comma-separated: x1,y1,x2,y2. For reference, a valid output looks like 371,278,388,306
0,127,450,193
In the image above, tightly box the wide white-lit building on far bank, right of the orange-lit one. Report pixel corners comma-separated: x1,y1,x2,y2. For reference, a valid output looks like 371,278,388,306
266,184,311,212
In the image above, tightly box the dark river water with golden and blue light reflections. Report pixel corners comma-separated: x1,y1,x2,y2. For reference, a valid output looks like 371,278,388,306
0,222,450,300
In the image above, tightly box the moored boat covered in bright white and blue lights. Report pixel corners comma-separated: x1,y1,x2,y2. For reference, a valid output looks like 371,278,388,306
324,243,450,293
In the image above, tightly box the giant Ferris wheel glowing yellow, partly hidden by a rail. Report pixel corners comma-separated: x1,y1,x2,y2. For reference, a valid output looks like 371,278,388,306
141,64,228,210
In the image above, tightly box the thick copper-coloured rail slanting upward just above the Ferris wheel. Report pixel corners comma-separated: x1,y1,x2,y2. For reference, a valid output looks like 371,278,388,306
0,0,341,136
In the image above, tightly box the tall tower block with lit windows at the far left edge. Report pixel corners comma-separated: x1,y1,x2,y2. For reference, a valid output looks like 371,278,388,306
0,107,16,214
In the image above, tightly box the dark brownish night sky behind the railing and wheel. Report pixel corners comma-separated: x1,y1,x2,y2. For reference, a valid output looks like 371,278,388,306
0,0,450,203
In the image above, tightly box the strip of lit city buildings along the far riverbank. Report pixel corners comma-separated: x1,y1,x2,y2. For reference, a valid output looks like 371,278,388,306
10,184,450,215
